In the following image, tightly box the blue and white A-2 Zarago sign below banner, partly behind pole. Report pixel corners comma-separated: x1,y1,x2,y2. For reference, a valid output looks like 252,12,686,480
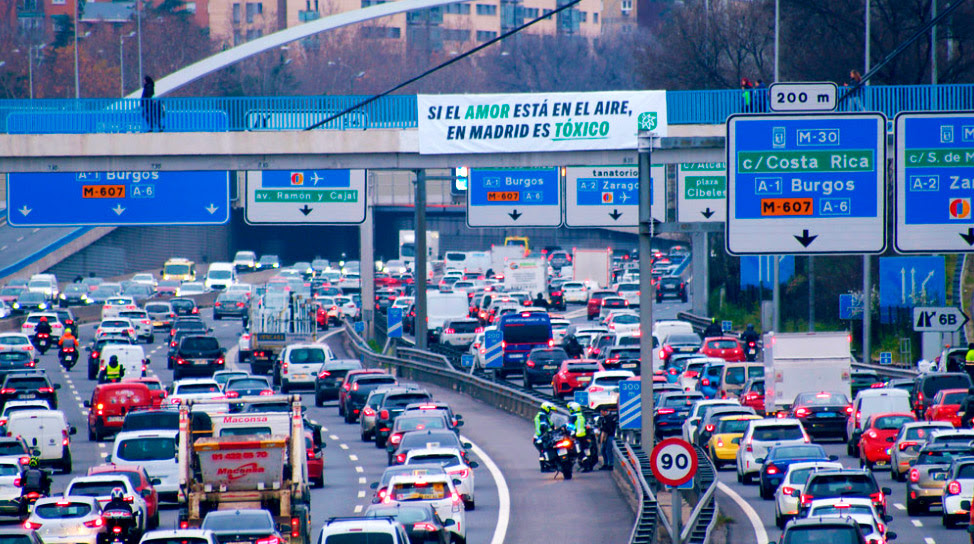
565,164,666,227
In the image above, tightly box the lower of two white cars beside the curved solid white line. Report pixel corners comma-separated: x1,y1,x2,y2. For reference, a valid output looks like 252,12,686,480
382,474,467,542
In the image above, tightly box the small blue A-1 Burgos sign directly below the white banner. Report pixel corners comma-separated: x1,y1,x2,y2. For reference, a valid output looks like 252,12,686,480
467,168,561,227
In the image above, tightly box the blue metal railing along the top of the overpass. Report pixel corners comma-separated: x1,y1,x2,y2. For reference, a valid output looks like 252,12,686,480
0,84,974,134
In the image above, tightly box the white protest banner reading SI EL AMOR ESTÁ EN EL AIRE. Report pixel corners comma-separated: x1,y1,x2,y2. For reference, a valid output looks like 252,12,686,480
416,91,667,155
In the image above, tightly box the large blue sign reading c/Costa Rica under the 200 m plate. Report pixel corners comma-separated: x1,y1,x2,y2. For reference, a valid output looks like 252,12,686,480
725,113,886,255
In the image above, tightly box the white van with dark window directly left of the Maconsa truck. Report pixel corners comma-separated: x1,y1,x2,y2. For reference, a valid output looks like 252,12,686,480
106,430,179,502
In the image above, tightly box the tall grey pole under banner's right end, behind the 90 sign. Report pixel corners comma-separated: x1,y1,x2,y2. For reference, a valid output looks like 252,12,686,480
638,131,660,448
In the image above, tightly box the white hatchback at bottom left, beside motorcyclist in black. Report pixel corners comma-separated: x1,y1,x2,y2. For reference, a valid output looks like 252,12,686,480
24,496,105,544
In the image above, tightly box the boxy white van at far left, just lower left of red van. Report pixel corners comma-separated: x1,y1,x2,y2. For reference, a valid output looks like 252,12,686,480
6,410,78,474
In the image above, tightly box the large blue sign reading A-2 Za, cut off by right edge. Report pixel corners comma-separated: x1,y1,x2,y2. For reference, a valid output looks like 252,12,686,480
894,112,974,253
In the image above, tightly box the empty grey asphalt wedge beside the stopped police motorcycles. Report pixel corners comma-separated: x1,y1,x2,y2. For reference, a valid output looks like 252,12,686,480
329,335,635,543
